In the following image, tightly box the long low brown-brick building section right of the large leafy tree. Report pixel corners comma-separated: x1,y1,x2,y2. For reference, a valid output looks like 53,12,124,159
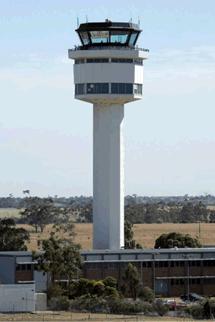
82,248,215,296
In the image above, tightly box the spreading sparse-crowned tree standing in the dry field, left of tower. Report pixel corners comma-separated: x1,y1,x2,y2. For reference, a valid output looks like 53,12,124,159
21,197,61,232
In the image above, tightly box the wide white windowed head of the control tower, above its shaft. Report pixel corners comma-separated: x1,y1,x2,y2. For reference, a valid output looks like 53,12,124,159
69,20,148,104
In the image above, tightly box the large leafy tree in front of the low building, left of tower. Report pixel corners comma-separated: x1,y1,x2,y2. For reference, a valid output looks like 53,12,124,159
37,233,82,287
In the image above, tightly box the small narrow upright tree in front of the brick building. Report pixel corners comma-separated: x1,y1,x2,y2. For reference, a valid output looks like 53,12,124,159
123,263,140,300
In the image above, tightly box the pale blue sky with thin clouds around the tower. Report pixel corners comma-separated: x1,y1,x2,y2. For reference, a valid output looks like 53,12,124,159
0,0,215,196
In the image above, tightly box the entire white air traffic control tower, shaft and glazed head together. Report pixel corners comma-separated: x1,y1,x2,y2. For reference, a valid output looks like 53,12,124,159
69,20,148,250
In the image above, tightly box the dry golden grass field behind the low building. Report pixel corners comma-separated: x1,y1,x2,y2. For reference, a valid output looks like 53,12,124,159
22,223,215,250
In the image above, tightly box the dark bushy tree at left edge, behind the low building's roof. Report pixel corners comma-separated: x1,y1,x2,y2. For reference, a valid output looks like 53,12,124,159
0,218,29,251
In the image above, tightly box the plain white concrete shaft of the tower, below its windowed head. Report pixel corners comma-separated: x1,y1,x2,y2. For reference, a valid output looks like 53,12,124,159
93,104,124,250
